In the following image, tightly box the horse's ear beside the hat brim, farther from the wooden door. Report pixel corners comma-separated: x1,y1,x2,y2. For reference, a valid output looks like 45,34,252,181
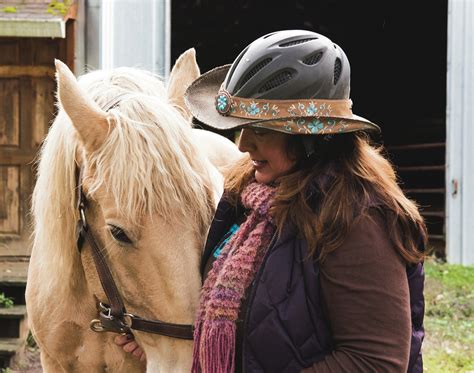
168,48,201,120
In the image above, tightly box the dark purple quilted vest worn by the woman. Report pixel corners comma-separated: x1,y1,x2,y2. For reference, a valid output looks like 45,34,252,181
202,196,424,373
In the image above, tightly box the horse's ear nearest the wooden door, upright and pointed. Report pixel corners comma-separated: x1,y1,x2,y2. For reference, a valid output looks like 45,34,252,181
54,60,110,152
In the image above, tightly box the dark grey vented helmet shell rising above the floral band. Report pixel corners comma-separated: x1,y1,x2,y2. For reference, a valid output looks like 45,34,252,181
224,30,350,100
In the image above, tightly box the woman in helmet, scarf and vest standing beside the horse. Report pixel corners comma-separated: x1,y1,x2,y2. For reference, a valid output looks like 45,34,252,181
118,30,426,372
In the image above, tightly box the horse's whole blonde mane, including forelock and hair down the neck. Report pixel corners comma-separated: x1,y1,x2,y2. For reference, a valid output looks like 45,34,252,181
33,68,217,299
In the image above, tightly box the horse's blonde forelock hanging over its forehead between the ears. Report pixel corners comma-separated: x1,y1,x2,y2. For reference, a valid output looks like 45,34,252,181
90,94,212,230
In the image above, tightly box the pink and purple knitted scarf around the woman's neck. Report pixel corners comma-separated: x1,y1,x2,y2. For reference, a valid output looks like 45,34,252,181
191,182,275,373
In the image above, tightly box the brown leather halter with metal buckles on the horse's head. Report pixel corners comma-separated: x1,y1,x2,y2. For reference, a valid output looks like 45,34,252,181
76,167,194,339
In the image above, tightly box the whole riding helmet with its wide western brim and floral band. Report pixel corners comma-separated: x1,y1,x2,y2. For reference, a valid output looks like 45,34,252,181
185,30,380,135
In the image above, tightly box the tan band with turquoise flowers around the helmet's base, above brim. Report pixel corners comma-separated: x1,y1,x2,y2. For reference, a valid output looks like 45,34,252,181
216,89,352,119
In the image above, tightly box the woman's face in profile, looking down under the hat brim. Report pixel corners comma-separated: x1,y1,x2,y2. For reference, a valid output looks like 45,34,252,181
239,128,296,184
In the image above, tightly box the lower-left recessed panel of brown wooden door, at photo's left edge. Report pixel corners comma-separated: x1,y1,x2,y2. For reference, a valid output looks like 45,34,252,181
0,166,20,234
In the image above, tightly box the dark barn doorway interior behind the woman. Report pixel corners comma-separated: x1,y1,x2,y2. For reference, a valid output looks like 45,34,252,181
171,0,447,255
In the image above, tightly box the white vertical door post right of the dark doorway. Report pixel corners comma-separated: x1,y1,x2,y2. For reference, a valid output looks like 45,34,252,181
446,0,474,265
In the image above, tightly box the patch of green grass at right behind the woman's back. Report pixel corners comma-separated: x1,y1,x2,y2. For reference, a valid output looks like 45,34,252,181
423,260,474,373
